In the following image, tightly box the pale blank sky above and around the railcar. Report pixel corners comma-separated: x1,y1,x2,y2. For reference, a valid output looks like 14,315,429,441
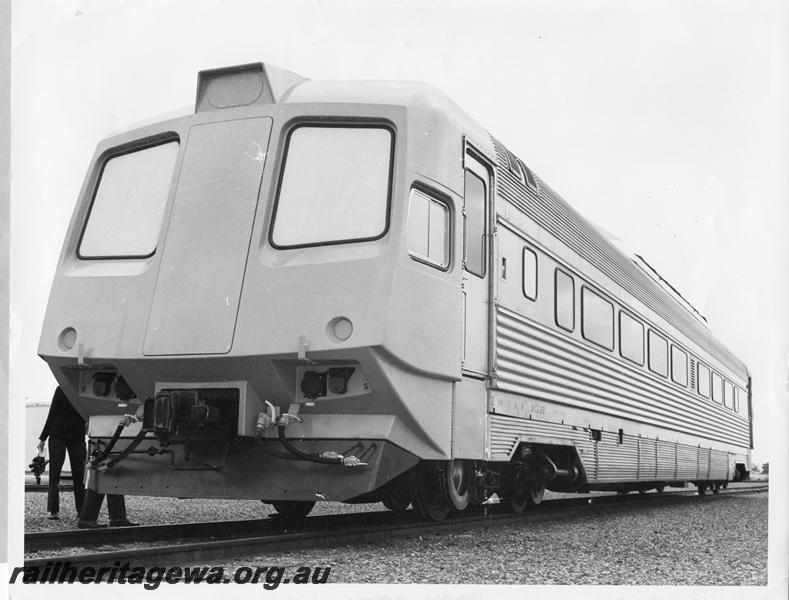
9,0,789,592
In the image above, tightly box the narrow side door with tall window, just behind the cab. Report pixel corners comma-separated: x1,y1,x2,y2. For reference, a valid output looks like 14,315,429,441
462,148,492,379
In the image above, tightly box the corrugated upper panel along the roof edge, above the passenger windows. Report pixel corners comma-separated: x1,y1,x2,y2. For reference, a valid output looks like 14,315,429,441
491,138,748,378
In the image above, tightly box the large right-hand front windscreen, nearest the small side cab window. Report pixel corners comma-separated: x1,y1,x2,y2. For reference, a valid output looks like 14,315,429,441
271,126,394,248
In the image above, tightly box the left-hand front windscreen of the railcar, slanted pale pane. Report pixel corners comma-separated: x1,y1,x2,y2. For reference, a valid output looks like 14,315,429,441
78,141,178,258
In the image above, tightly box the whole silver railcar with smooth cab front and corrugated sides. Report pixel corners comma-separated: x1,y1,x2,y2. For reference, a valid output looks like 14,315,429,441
39,63,752,520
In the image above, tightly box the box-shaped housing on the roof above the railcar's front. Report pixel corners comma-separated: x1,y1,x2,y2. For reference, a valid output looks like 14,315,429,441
195,63,307,113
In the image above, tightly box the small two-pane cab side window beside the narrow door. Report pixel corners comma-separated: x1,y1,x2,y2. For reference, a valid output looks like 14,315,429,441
407,189,449,269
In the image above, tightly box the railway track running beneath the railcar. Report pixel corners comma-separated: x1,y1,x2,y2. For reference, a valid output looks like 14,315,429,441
25,484,768,567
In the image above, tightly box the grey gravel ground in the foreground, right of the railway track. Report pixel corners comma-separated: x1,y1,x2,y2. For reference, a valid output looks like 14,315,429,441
228,493,767,585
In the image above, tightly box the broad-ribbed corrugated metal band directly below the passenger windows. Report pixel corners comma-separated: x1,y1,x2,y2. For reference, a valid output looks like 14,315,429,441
495,306,749,448
